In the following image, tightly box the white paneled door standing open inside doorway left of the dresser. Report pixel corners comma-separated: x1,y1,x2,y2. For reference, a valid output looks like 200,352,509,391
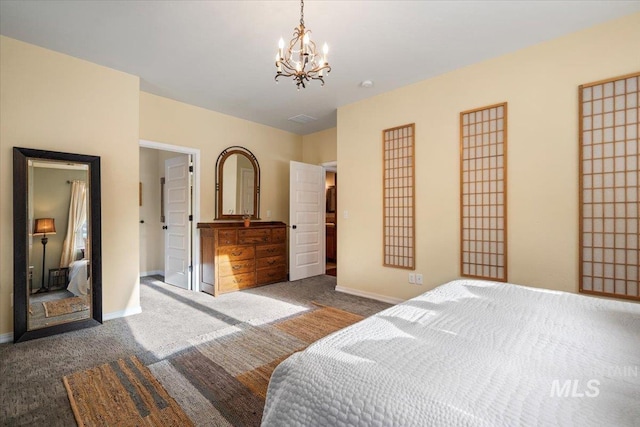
164,155,191,289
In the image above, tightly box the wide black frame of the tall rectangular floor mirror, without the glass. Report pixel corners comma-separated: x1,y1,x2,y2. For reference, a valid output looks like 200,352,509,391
13,147,102,343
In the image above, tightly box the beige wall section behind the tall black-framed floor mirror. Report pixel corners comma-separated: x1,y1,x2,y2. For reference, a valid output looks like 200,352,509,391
0,37,140,334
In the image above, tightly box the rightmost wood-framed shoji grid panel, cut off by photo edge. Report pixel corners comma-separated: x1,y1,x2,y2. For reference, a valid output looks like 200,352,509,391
579,73,640,300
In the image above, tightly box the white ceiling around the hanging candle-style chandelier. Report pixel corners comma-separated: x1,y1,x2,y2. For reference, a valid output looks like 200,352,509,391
0,0,640,135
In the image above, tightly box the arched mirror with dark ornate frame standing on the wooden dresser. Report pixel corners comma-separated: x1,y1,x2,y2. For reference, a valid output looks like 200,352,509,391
216,146,260,220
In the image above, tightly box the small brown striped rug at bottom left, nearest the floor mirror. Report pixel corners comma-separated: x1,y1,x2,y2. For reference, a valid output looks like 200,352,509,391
63,356,193,427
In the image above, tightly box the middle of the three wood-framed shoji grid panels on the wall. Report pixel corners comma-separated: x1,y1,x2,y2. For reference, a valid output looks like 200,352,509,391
460,102,507,282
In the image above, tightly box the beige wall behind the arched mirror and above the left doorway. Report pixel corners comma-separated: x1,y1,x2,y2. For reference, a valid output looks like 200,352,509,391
140,92,302,222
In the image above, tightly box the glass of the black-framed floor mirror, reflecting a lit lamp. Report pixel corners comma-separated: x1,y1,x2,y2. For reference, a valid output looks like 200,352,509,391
27,159,91,330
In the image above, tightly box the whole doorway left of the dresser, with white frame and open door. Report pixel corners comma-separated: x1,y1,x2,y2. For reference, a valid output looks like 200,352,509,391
139,140,200,291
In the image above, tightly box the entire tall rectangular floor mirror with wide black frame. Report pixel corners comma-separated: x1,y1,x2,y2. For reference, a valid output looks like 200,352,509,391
13,147,102,342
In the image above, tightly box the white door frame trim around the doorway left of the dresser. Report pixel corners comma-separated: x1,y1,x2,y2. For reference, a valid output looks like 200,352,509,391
138,139,200,292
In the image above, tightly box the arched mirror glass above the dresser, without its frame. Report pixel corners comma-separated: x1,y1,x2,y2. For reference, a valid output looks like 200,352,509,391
222,154,255,215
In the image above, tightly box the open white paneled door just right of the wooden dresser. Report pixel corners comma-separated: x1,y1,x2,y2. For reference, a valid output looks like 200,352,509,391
289,161,326,280
